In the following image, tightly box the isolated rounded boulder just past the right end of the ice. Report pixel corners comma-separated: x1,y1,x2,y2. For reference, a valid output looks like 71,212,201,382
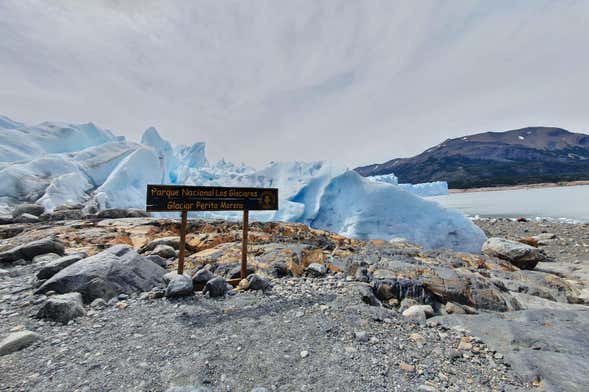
482,237,548,269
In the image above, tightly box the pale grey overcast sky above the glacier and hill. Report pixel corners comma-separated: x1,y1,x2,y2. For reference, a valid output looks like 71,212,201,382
0,0,589,166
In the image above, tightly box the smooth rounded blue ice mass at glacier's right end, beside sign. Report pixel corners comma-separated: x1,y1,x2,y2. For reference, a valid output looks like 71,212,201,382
311,171,486,253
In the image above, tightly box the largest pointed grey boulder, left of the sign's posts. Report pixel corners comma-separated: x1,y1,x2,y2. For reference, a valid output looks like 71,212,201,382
36,245,166,303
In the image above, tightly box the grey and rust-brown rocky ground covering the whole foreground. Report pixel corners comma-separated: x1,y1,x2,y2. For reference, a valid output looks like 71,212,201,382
0,214,589,392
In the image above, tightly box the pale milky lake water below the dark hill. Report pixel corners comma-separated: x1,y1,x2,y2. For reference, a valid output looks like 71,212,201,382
427,185,589,222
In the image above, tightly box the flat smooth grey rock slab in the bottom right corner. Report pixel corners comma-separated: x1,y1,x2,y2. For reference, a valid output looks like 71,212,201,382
435,306,589,392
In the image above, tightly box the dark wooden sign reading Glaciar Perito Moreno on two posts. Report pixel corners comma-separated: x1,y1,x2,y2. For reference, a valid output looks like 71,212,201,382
146,185,278,279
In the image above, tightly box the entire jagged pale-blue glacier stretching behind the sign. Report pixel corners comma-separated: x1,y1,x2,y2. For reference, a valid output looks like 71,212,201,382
0,117,485,253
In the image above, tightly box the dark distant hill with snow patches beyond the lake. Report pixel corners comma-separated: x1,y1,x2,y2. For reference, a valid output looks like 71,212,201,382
356,127,589,189
